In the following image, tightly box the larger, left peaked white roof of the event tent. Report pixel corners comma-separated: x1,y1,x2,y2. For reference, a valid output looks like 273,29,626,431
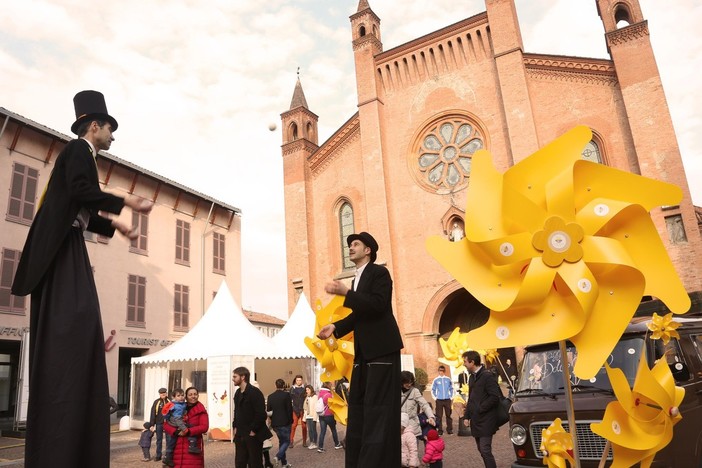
132,281,280,364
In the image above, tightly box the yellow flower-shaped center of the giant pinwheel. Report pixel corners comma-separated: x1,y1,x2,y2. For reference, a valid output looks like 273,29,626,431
531,216,584,268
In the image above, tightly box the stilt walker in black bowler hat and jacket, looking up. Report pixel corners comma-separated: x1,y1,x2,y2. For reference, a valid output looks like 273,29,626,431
318,232,403,468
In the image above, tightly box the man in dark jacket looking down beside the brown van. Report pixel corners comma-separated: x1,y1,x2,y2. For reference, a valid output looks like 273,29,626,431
463,351,501,468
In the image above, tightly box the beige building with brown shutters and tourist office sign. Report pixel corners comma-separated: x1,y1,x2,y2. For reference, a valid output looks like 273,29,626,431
0,108,241,418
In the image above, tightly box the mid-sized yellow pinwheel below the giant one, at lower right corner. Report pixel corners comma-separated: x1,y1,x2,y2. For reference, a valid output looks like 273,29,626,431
590,354,685,468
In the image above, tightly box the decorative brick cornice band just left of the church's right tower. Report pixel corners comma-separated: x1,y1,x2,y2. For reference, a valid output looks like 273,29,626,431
524,55,617,86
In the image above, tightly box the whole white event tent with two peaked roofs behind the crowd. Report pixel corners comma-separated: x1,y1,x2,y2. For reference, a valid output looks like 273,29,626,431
129,282,319,439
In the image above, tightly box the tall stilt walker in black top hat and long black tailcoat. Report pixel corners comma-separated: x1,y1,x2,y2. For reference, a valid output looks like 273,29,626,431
12,91,153,468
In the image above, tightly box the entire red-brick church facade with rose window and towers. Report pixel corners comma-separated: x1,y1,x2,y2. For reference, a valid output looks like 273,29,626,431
281,0,702,370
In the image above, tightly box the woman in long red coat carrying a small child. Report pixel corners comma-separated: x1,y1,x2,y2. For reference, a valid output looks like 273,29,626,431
163,387,210,468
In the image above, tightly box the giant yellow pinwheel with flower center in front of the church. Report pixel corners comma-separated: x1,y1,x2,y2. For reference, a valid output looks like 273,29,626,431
427,126,690,378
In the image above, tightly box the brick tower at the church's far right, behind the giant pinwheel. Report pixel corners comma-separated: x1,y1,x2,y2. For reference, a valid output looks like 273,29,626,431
597,0,702,294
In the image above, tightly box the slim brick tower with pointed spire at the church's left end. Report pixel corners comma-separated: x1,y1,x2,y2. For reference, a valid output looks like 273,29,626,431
280,76,319,311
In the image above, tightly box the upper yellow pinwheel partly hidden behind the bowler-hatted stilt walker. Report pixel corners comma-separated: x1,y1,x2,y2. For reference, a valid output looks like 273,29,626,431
305,296,354,382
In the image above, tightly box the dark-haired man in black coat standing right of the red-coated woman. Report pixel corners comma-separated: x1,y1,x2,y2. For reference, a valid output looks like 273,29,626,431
232,367,273,468
